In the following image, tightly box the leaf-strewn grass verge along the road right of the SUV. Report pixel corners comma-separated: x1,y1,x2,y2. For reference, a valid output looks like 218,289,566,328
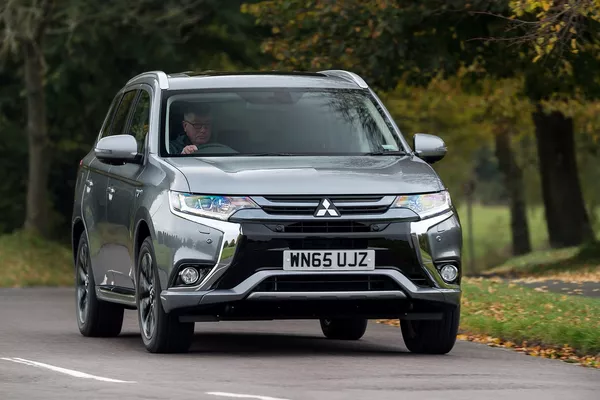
380,278,600,368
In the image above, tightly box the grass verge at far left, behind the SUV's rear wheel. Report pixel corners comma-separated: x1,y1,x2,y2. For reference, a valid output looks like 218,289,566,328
0,232,73,287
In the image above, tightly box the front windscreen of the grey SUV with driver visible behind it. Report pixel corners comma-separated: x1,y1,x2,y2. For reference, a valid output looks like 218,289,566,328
163,89,404,156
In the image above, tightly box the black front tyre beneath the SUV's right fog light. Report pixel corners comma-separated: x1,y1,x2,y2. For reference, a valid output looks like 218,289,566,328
400,306,460,354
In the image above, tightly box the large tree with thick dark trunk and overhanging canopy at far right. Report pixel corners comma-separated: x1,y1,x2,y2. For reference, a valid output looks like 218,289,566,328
243,0,600,247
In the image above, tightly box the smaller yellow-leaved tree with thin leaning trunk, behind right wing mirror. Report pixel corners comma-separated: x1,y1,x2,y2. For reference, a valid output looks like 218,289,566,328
382,71,533,255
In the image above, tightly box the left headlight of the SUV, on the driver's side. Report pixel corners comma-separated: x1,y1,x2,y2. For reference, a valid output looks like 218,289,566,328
169,192,259,221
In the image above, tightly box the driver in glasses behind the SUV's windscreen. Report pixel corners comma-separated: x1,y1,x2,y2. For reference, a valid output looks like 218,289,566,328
169,104,212,154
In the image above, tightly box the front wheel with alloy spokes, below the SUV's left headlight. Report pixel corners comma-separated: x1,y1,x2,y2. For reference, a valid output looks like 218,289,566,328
136,237,194,353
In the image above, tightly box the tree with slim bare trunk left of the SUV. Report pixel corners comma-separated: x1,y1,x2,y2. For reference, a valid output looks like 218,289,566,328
0,0,240,235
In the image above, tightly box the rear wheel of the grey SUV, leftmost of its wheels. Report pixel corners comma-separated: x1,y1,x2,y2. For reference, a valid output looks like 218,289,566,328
75,232,125,337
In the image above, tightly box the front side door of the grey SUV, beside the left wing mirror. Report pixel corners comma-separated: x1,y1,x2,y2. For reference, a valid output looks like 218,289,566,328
107,85,152,289
